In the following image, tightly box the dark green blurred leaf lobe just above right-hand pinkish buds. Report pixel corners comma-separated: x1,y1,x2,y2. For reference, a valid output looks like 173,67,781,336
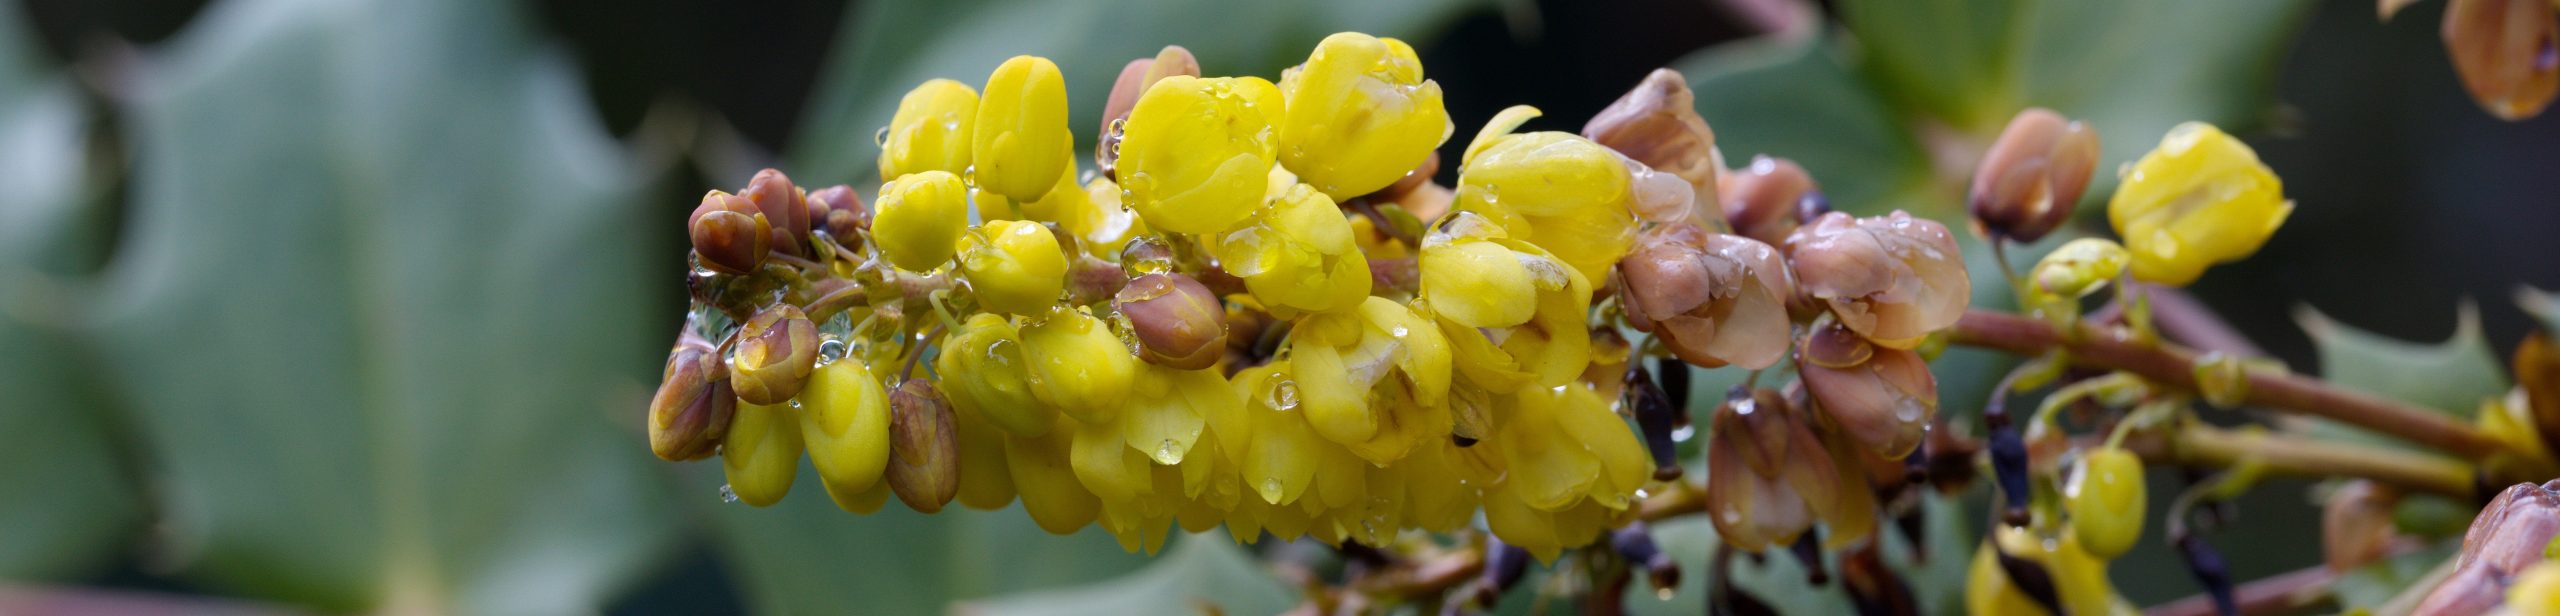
1672,25,1946,215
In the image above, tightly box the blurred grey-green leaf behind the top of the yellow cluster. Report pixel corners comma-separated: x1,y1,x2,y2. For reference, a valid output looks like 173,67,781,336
791,0,1485,181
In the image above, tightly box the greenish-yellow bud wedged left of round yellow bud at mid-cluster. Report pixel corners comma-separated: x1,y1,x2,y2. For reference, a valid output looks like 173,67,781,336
934,312,1057,437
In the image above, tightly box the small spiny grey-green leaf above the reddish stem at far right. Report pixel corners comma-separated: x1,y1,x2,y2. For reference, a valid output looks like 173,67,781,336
2294,302,2509,442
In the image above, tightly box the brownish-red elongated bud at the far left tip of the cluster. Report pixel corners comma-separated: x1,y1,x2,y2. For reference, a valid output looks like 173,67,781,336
648,335,737,463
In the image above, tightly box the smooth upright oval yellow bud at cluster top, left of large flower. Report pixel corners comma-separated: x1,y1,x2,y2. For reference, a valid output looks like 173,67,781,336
970,56,1075,202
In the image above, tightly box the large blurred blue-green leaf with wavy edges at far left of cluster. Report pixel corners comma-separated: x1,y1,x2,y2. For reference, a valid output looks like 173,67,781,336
97,0,678,613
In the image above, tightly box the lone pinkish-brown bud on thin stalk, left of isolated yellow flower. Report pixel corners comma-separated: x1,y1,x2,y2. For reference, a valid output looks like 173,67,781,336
1969,107,2097,243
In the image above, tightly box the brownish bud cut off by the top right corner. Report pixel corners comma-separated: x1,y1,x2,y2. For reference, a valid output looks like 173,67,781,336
2445,0,2560,123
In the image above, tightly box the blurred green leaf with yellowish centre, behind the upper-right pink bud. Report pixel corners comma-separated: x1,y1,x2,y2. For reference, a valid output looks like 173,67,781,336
1674,0,2312,220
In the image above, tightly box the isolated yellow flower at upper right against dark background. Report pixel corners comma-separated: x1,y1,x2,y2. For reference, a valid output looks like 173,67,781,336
2107,123,2294,286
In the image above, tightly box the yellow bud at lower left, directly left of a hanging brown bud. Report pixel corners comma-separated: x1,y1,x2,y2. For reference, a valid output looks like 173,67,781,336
799,360,888,513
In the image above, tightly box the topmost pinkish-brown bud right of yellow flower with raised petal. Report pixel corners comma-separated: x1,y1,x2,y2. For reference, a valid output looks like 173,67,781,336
1582,69,1723,225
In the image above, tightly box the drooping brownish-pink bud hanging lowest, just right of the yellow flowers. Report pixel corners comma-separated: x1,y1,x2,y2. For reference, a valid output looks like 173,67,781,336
1708,391,1864,552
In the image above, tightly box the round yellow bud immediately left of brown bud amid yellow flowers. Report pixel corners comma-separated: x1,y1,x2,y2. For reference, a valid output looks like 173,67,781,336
1021,307,1137,424
